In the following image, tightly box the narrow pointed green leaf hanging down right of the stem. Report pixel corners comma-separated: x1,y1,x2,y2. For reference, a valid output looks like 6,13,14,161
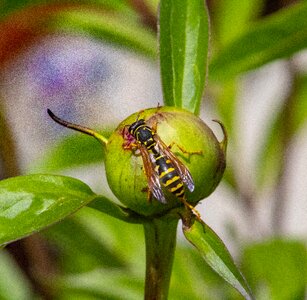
183,220,253,299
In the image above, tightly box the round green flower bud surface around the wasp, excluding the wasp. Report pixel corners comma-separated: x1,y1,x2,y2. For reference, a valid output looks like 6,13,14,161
105,107,227,216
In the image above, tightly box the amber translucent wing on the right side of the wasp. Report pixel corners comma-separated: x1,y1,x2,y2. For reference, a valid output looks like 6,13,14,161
154,134,195,192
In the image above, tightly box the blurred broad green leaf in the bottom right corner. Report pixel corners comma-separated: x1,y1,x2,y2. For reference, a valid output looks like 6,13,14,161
243,240,307,300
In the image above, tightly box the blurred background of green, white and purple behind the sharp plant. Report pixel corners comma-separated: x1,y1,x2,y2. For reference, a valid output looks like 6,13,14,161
0,0,307,299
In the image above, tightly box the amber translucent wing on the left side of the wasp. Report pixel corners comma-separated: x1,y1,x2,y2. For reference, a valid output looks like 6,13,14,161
139,145,166,203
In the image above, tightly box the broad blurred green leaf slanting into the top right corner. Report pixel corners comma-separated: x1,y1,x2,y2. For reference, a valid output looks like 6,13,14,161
210,1,307,81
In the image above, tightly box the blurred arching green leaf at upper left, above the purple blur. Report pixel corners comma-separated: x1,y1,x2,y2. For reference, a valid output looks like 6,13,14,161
46,8,157,58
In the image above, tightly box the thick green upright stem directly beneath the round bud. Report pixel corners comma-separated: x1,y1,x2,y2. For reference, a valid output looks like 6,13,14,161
144,218,178,300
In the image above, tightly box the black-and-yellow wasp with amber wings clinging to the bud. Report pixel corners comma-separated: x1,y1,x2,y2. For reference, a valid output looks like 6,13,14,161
123,114,201,217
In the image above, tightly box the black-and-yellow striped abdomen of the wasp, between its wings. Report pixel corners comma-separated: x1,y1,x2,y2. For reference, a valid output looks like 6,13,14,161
155,154,184,198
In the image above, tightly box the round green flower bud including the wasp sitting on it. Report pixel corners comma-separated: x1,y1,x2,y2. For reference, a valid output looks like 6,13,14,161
106,107,226,216
